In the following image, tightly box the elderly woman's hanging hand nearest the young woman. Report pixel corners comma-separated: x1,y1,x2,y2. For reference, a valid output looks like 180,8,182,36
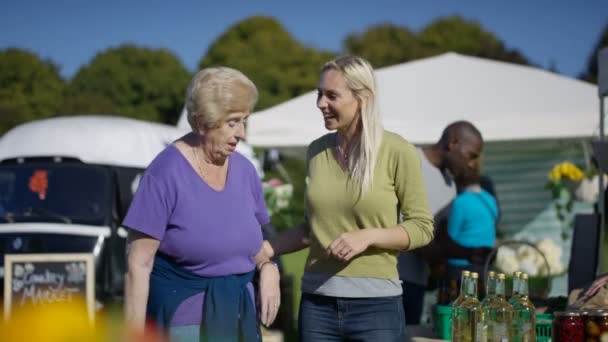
258,261,281,326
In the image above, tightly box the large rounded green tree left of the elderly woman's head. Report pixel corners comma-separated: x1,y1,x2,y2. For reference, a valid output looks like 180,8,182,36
63,45,190,124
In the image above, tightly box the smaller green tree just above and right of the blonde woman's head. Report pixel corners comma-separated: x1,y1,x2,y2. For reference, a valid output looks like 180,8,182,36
344,24,428,68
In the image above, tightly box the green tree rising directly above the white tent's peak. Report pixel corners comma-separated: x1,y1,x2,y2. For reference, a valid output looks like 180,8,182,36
419,16,529,64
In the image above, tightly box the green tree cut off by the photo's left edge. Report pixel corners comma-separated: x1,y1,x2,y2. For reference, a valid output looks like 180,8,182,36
0,48,65,133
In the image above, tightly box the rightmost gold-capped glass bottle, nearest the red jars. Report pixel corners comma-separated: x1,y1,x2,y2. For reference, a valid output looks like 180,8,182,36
513,273,536,342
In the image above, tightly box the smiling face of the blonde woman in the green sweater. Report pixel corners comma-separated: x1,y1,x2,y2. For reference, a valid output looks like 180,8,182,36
317,69,359,130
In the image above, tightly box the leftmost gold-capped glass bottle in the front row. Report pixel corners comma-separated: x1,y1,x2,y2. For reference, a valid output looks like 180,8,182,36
452,272,485,342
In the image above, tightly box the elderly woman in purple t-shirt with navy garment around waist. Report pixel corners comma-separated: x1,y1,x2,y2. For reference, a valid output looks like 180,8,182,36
124,67,280,341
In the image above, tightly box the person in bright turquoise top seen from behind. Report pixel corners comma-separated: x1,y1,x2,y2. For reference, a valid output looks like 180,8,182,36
447,159,498,279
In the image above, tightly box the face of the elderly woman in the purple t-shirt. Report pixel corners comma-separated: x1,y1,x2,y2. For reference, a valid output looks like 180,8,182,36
202,113,249,157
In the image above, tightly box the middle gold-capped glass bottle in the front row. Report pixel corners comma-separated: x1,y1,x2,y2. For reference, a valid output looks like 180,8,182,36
483,273,513,342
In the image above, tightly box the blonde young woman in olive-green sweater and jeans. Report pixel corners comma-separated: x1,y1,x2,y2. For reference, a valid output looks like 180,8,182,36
265,56,433,342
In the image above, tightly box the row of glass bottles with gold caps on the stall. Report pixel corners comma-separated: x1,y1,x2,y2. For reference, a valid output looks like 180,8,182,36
452,271,536,342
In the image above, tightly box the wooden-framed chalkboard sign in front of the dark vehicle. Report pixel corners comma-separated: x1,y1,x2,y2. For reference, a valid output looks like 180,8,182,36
4,254,95,320
